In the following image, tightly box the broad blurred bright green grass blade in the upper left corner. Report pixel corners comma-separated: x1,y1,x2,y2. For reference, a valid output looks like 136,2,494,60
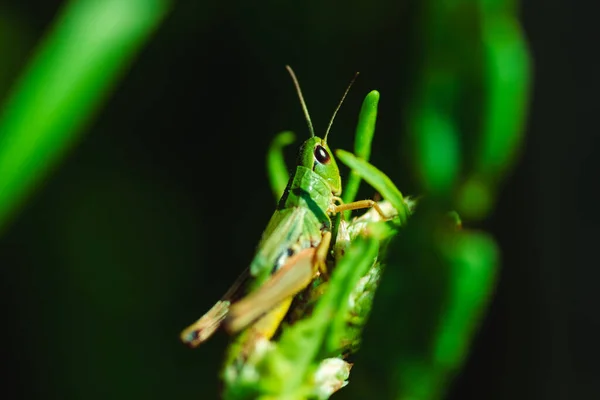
0,0,169,229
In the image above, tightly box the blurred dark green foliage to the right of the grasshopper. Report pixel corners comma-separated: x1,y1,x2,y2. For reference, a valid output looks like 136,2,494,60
356,1,530,400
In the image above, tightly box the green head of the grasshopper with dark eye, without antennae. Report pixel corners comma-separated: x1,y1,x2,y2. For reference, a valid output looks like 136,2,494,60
298,136,342,196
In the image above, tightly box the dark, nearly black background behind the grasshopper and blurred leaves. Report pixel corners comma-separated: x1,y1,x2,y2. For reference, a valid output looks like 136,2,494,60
0,0,600,399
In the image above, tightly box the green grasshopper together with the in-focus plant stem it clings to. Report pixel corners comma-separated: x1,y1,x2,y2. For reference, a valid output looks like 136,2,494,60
181,67,411,399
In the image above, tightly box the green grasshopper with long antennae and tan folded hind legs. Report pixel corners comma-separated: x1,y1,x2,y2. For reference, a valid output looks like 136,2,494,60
181,66,396,347
